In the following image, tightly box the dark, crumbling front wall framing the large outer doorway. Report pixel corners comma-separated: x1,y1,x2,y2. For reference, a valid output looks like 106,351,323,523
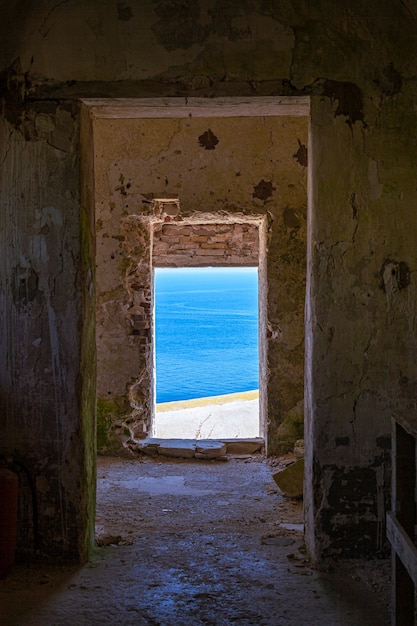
0,0,417,559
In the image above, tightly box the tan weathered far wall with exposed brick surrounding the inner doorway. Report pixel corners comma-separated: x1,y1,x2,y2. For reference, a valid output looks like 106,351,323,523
94,111,307,454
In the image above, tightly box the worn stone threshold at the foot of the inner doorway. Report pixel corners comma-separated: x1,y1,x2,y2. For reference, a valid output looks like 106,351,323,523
136,437,265,459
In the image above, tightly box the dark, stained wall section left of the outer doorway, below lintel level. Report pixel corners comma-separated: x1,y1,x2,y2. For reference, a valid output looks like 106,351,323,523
0,105,91,560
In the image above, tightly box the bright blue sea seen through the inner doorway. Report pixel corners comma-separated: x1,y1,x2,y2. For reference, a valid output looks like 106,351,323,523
155,267,259,403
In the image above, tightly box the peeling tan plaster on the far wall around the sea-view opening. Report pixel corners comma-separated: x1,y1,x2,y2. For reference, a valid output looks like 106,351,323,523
95,117,307,453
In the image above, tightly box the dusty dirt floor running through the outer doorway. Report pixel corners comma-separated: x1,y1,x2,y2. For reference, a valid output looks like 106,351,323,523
0,456,389,626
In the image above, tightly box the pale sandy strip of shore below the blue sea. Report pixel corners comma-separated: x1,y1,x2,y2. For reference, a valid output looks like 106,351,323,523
153,391,259,439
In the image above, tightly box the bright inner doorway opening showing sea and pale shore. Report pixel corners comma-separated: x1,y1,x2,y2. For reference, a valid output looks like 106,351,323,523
152,267,260,439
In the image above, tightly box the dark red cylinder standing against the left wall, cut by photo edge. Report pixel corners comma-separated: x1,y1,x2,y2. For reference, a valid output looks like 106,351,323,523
0,467,19,578
